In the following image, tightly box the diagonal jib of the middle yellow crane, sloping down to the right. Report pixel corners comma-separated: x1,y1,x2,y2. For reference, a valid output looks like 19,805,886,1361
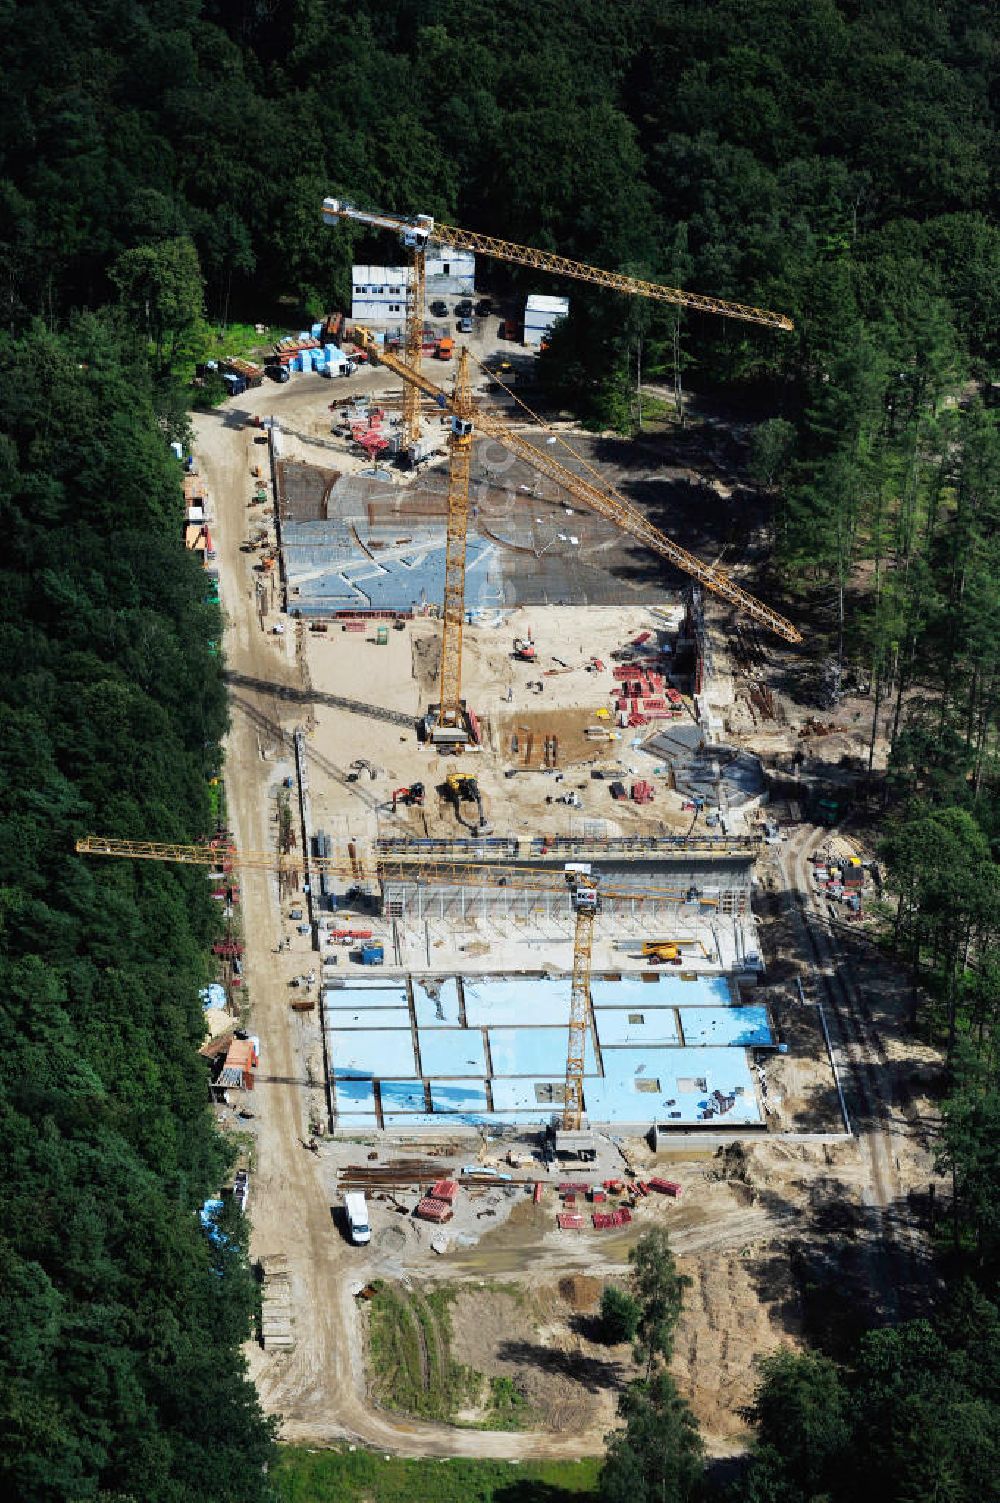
355,328,802,642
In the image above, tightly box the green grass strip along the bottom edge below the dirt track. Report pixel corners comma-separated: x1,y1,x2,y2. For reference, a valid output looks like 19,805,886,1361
272,1446,600,1503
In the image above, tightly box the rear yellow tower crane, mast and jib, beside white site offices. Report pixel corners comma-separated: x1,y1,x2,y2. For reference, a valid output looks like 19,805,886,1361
323,190,794,445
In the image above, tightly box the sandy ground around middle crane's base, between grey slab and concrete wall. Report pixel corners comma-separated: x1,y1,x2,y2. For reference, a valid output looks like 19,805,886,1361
304,606,706,859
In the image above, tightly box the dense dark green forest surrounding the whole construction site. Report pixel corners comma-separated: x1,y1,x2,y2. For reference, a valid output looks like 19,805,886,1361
0,0,1000,1503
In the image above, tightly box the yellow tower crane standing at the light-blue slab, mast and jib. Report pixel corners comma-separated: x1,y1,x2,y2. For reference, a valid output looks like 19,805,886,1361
75,836,733,1156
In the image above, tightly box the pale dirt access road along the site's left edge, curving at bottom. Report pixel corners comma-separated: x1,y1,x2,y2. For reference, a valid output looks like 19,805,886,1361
194,388,628,1459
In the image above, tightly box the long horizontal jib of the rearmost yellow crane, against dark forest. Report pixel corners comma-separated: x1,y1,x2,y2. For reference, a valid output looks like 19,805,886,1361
323,198,795,331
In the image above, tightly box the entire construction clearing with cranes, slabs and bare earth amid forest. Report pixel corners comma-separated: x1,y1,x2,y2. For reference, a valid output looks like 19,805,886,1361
81,200,932,1459
